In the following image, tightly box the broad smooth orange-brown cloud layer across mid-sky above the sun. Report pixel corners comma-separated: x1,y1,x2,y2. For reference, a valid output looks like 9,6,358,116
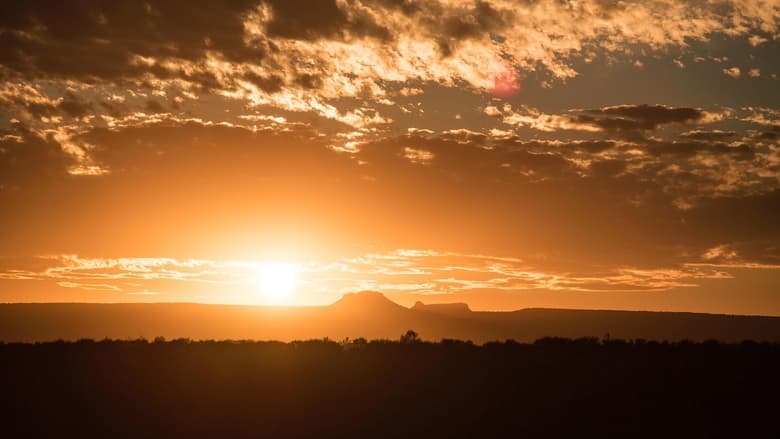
0,115,780,282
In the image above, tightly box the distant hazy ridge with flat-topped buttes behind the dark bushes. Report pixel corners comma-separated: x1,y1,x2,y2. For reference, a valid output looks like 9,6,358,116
0,292,780,343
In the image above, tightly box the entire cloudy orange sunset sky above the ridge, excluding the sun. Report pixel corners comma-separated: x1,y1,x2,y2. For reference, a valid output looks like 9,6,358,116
0,0,780,315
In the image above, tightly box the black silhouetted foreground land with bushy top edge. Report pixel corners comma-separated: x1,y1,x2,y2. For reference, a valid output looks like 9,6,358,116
0,338,780,438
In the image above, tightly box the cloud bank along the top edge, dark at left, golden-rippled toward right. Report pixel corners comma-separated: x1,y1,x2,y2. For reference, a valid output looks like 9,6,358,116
0,0,780,111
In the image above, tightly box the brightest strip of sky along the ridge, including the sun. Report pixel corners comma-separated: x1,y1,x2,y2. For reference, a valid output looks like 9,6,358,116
0,249,780,315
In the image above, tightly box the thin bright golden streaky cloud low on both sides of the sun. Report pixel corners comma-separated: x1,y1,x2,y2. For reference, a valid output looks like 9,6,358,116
0,247,748,302
